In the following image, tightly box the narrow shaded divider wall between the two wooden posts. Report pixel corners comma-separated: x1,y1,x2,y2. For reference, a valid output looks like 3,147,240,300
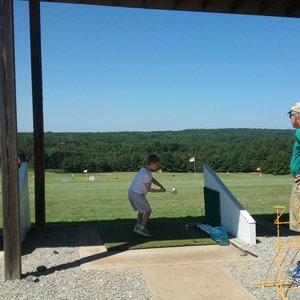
19,162,31,242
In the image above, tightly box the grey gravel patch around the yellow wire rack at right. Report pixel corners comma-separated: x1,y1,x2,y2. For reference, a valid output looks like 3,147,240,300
223,237,300,300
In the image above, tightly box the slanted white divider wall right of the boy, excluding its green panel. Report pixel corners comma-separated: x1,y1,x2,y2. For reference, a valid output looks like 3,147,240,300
203,164,256,245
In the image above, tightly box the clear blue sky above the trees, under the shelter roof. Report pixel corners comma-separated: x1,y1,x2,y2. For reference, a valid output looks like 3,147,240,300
15,1,300,131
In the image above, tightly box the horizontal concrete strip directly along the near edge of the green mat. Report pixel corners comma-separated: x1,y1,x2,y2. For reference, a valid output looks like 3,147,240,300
80,245,255,269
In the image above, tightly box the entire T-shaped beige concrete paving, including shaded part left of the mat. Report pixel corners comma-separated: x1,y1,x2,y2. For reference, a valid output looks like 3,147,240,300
79,227,255,300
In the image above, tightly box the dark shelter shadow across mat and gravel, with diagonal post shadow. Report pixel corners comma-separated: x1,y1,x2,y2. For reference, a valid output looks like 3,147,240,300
7,214,299,276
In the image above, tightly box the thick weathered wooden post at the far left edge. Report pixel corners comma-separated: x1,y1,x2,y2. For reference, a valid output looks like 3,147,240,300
0,0,21,280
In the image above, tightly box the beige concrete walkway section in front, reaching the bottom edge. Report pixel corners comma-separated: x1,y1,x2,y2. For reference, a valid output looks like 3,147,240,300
143,263,256,300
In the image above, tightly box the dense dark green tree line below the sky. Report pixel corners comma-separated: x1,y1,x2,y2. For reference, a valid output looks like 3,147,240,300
18,129,294,174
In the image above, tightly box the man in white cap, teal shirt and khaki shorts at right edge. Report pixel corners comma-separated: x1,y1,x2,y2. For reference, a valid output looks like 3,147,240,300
289,102,300,232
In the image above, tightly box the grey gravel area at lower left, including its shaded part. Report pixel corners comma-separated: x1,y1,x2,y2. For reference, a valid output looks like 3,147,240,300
0,227,152,300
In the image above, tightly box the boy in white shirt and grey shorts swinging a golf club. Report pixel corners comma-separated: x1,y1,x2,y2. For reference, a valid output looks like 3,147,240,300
128,154,166,237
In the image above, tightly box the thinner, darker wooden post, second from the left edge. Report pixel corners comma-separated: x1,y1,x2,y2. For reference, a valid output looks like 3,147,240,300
29,0,46,229
